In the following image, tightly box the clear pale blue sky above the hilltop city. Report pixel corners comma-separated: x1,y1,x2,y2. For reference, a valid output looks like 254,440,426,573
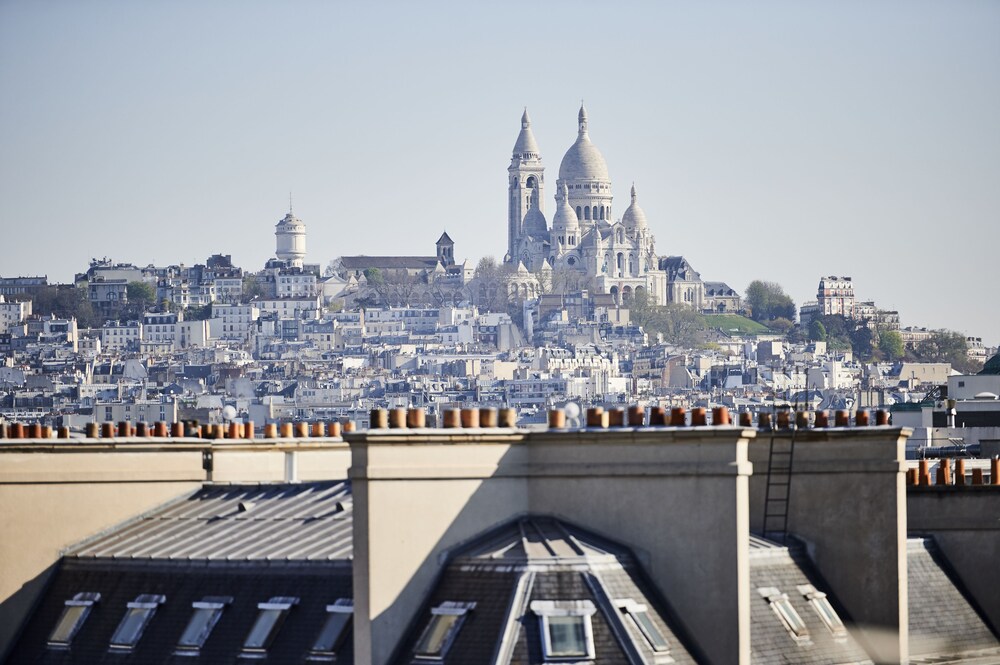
0,0,1000,345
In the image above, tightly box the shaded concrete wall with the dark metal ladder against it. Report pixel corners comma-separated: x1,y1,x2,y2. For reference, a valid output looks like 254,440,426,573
749,427,909,663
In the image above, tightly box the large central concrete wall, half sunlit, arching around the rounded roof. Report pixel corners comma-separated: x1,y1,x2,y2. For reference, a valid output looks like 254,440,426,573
346,428,754,665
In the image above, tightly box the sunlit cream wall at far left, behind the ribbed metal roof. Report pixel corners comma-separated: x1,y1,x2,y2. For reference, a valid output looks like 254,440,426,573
0,439,350,660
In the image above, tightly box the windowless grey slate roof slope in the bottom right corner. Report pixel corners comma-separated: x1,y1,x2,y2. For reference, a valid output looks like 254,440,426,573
906,538,1000,662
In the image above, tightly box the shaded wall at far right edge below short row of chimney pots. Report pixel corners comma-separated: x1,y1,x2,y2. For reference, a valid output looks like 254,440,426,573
906,485,1000,635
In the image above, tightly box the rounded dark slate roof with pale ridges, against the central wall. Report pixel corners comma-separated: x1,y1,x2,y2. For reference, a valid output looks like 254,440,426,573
392,517,698,665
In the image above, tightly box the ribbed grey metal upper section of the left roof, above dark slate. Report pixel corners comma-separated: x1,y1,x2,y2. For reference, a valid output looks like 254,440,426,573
69,481,353,561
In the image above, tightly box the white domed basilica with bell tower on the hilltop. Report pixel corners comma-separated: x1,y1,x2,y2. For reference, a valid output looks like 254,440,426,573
505,105,739,311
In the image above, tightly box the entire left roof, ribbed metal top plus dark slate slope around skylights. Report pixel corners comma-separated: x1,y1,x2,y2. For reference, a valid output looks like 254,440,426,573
8,482,353,665
